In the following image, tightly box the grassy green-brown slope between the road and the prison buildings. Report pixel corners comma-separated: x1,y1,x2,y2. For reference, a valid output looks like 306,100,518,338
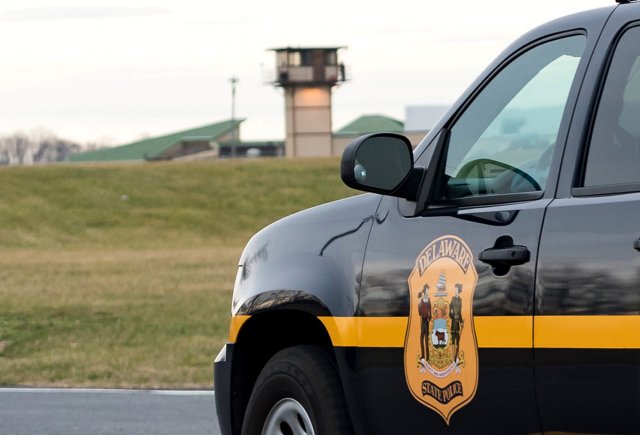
0,159,353,388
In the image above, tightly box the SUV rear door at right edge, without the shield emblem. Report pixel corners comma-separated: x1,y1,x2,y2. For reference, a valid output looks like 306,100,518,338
534,5,640,434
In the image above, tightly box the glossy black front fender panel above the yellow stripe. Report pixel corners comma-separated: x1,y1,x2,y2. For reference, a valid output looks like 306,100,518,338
232,195,380,316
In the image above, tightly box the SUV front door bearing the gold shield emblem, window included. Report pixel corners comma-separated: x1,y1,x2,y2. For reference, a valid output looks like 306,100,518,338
354,29,595,434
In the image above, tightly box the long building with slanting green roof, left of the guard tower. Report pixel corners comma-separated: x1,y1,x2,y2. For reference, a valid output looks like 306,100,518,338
69,119,244,162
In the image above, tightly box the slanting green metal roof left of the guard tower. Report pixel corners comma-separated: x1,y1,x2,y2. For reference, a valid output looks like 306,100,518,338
69,119,244,162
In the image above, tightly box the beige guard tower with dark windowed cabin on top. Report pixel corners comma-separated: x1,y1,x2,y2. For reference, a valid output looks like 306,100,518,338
273,47,347,157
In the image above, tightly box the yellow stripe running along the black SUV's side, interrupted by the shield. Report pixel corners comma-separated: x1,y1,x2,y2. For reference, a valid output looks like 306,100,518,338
229,315,640,349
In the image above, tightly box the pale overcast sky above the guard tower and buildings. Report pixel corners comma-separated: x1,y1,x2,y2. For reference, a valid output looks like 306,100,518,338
0,0,614,145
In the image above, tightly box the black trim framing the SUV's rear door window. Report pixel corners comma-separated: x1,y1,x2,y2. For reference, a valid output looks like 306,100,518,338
571,21,640,197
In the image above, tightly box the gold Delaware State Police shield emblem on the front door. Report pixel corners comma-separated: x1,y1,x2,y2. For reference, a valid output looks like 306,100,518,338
404,236,478,425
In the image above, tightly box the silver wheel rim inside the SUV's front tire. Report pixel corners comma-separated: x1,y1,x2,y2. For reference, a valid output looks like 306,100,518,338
262,398,315,435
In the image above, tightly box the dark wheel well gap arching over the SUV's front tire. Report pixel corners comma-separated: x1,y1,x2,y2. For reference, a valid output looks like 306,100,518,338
231,310,335,433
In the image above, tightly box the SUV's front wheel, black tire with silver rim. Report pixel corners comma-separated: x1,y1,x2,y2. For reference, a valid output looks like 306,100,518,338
242,345,353,435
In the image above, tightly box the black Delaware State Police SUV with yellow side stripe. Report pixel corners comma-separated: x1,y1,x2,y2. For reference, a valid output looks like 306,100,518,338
215,1,640,435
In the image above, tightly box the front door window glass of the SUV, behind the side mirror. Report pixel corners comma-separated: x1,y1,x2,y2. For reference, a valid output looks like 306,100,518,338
442,35,586,199
